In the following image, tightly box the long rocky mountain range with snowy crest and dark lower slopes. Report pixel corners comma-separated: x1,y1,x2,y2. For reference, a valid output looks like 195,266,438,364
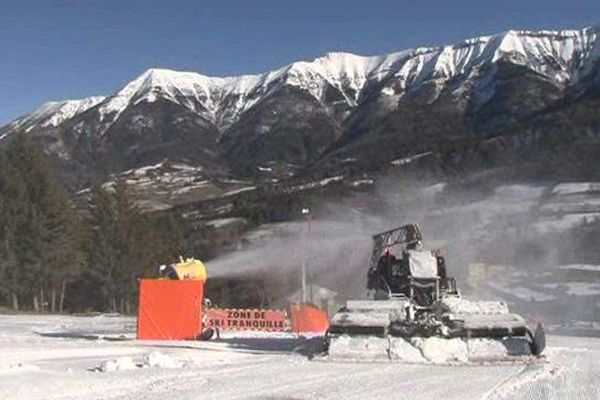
0,27,600,190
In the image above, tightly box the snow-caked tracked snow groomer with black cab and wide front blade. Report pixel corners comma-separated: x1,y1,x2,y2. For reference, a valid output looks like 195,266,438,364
327,224,546,363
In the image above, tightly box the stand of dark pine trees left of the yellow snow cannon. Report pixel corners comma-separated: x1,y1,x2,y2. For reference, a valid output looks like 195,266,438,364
0,134,184,313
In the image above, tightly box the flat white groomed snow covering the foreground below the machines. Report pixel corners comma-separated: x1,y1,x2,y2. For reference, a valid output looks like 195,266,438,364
0,315,600,400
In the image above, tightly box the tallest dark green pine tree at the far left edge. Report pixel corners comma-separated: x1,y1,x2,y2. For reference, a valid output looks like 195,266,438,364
0,134,83,311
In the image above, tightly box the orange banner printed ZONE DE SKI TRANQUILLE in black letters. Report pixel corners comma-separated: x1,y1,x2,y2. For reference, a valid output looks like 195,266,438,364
205,308,287,332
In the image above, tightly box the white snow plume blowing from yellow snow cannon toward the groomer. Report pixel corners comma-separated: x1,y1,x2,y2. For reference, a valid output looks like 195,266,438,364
207,177,443,298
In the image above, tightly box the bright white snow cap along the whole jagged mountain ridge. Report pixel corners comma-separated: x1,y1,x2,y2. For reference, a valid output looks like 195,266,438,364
9,25,600,133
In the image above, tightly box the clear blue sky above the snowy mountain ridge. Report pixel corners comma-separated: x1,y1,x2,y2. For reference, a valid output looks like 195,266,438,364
0,0,600,124
